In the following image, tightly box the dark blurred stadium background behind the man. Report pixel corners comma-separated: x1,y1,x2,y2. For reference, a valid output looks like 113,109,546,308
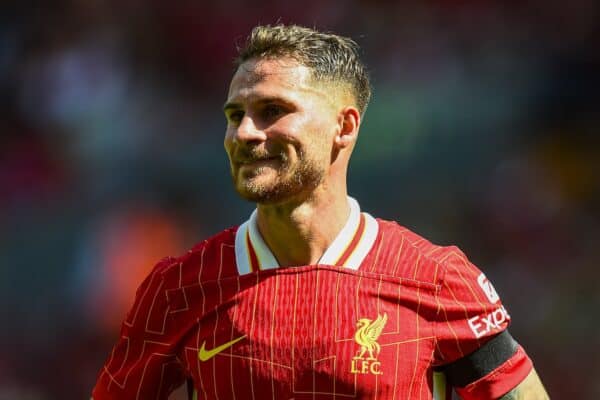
0,0,600,400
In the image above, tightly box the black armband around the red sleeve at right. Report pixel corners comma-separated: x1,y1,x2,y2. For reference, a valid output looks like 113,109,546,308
443,331,519,387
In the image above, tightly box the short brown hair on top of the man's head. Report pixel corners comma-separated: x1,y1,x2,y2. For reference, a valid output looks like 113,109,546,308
235,25,371,114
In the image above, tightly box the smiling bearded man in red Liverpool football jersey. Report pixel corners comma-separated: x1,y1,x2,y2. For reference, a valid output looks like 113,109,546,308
93,26,547,400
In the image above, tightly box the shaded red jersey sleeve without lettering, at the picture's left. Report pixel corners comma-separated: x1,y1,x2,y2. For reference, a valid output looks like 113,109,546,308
92,260,185,400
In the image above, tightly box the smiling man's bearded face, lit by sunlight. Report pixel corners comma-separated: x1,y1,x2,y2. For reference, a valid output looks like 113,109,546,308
224,59,337,204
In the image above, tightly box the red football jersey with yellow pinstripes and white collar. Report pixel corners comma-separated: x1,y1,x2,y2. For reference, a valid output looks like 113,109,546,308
93,199,532,400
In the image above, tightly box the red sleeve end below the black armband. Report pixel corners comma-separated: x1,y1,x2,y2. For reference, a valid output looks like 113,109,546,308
456,346,533,400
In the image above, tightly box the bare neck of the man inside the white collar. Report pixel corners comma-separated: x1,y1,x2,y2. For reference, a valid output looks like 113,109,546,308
257,190,350,266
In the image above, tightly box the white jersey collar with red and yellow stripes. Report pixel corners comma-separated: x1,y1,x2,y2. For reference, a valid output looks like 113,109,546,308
235,197,379,275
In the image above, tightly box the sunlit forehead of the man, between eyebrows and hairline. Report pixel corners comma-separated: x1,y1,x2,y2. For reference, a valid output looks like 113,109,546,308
227,59,322,102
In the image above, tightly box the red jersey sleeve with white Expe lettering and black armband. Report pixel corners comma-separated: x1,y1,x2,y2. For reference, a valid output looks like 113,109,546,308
435,247,533,400
